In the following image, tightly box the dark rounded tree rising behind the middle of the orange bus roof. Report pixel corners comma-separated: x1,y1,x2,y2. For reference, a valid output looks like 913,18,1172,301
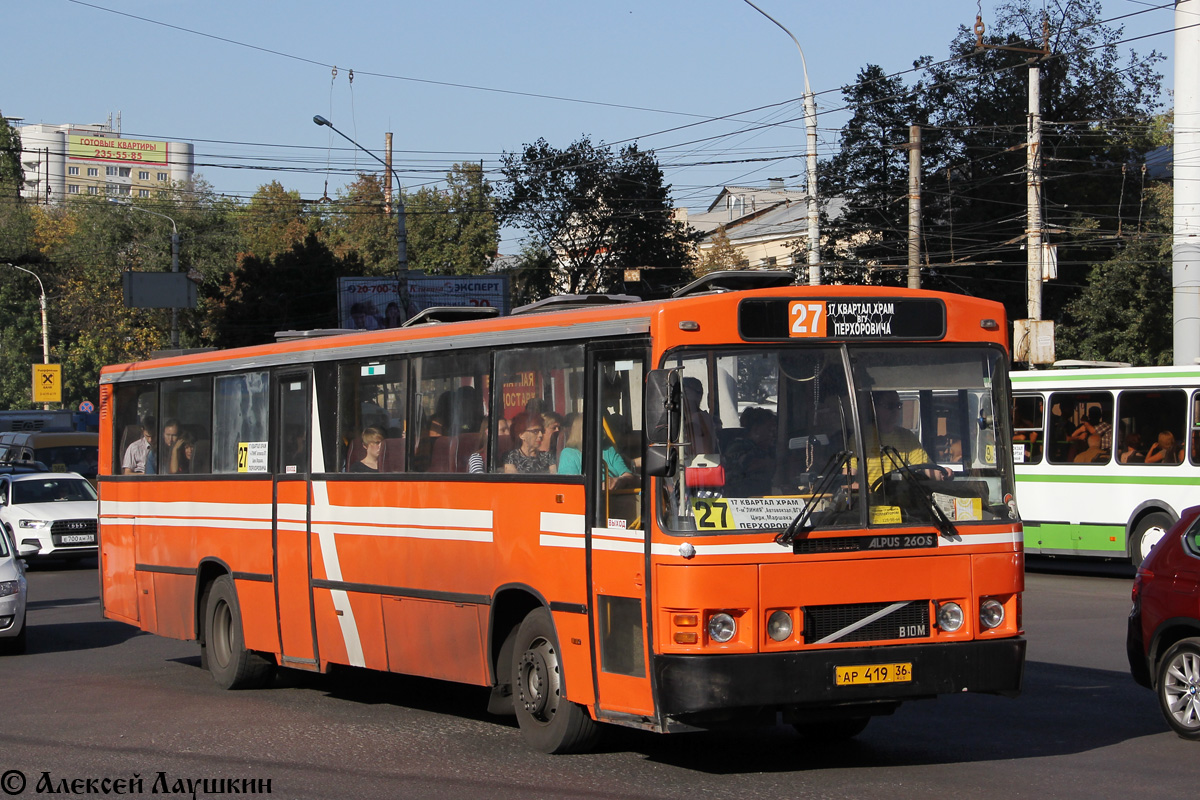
497,137,697,294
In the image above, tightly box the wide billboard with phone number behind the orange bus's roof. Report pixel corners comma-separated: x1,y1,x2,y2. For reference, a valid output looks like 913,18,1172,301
337,275,509,331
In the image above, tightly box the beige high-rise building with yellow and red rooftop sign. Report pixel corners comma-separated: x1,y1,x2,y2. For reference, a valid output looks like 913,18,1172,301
17,124,194,203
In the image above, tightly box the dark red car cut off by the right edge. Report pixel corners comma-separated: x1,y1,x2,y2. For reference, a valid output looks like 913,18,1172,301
1126,506,1200,740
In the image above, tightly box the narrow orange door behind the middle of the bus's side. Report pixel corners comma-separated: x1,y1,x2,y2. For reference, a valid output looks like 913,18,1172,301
271,373,317,669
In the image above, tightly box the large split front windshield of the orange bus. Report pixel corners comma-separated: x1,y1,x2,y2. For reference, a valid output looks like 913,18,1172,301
661,345,1016,533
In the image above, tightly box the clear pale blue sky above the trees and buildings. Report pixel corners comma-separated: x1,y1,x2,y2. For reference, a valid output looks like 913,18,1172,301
0,0,1174,253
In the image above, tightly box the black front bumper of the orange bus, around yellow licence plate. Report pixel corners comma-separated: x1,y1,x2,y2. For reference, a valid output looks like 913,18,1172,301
654,638,1025,717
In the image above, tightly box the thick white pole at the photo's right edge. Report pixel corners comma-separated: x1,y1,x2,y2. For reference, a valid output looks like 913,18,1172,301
1171,0,1200,367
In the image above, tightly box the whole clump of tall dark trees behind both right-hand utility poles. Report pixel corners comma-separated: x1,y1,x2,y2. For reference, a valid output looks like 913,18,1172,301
822,0,1163,317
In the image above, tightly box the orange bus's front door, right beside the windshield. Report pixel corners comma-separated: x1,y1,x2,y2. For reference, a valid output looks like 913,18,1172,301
584,347,654,715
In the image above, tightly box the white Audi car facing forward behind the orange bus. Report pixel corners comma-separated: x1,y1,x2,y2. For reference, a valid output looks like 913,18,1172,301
0,473,97,558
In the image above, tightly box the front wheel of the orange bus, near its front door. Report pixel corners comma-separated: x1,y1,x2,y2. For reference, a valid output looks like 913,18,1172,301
511,608,600,753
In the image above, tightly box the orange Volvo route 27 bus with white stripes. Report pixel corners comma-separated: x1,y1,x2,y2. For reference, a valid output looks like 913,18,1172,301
100,272,1025,752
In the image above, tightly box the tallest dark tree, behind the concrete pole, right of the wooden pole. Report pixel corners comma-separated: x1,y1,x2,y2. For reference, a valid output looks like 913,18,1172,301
917,0,1162,317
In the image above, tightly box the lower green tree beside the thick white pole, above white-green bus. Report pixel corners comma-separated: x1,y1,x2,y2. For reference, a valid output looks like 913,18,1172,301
1055,185,1175,367
